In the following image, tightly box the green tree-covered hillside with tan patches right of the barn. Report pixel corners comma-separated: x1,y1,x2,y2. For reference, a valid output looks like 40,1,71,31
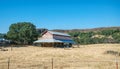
69,29,120,44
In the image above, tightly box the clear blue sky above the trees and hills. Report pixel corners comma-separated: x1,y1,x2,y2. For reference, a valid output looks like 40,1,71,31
0,0,120,33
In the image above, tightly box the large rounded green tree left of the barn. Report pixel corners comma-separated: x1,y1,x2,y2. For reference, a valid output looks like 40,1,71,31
7,22,38,44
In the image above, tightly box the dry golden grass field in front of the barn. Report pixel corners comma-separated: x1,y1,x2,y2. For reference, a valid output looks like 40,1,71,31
0,44,120,69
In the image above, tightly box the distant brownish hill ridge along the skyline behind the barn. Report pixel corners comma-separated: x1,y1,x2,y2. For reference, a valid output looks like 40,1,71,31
51,26,120,33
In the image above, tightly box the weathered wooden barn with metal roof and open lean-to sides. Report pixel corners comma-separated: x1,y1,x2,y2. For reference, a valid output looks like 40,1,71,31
34,31,74,47
